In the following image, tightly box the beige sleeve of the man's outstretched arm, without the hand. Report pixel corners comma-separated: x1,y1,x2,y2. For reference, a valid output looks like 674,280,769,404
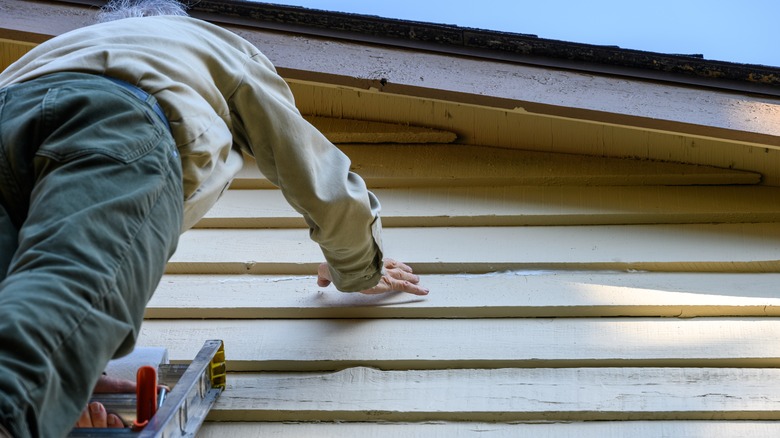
229,50,383,291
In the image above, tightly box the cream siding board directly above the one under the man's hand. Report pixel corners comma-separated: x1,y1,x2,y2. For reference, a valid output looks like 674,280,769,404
167,223,780,275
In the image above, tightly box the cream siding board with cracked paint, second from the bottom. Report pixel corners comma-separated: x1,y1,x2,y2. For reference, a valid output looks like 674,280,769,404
203,367,780,422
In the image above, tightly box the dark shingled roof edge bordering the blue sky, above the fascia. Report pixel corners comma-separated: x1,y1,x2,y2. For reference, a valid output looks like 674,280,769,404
62,0,780,96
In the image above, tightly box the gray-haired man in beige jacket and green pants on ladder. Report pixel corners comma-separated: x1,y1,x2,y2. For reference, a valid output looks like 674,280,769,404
0,0,428,437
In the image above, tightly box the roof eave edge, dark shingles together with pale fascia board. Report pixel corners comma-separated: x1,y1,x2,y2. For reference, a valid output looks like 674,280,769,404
0,0,780,148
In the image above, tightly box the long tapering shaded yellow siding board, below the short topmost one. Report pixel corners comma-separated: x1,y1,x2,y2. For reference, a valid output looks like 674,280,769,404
232,145,761,189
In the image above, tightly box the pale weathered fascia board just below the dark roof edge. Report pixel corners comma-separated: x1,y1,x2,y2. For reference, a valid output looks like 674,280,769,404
6,0,780,146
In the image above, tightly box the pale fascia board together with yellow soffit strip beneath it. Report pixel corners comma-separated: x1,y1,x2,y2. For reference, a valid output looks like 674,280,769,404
0,0,780,185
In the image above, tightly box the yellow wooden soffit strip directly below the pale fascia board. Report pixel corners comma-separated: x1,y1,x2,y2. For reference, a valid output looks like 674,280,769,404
288,81,780,186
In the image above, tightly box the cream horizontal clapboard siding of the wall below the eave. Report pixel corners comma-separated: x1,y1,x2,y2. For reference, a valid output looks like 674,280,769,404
139,139,780,437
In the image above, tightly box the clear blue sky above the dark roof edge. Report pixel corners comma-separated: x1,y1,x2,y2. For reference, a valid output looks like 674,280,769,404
253,0,780,67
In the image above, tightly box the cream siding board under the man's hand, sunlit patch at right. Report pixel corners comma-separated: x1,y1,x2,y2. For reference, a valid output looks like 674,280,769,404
146,271,780,319
